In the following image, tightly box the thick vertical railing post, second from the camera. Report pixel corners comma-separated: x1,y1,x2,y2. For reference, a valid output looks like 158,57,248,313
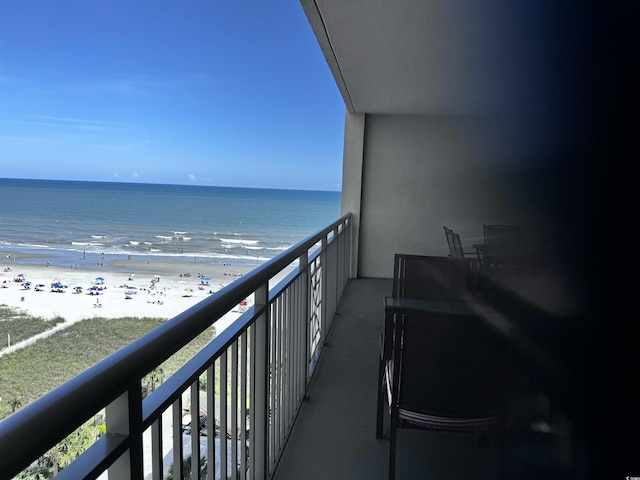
251,283,270,478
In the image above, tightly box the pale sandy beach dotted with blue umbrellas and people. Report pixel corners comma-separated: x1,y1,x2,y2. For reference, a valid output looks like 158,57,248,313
0,252,290,353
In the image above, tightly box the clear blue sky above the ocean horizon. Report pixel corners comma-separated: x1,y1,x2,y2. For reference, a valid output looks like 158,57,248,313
0,0,345,190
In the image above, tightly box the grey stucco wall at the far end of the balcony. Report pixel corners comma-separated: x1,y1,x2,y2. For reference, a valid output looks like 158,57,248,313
343,115,552,278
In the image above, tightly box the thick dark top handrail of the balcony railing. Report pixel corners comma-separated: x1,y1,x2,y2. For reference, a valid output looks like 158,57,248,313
0,213,351,475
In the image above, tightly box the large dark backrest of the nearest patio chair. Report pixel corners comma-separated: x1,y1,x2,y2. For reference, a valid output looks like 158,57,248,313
397,314,512,418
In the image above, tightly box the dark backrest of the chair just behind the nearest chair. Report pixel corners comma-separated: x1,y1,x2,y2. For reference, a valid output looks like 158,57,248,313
391,254,468,300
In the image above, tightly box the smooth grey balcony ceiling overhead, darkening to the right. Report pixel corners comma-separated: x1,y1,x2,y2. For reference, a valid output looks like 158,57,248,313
301,0,546,115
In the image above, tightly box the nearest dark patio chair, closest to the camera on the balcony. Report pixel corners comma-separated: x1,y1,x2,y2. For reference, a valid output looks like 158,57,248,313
384,312,512,479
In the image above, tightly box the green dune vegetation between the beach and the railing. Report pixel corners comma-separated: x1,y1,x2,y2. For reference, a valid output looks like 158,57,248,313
0,307,215,420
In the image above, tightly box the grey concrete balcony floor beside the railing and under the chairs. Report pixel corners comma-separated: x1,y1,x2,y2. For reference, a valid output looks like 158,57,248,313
274,279,498,480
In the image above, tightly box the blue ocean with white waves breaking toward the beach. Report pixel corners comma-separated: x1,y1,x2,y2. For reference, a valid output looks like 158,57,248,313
0,178,340,268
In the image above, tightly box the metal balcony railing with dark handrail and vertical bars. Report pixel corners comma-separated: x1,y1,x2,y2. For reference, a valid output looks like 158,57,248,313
0,214,351,480
